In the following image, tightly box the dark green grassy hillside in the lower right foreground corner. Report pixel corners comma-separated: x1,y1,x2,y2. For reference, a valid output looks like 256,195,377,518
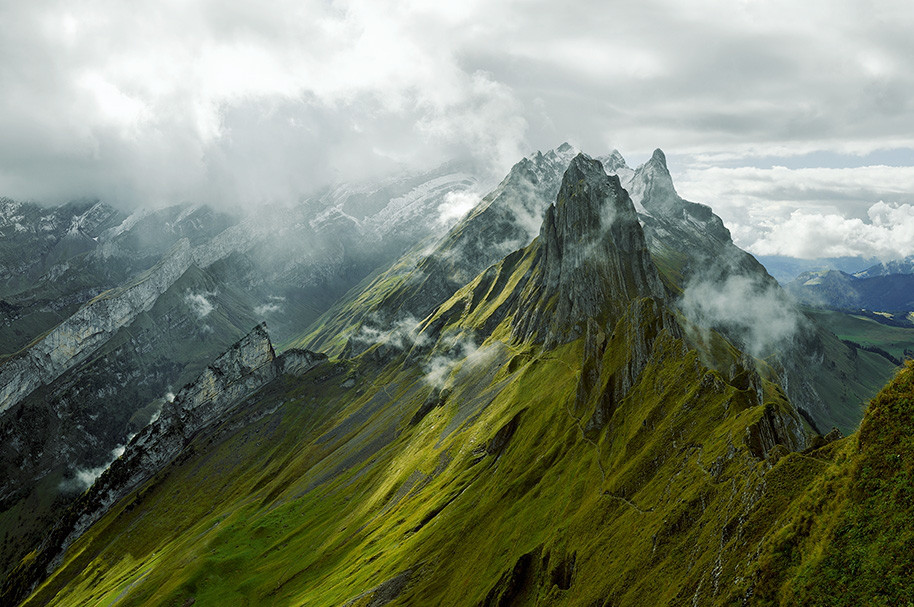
759,362,914,606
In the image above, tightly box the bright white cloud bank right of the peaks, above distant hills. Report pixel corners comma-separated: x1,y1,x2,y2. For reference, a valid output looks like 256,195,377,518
676,165,914,259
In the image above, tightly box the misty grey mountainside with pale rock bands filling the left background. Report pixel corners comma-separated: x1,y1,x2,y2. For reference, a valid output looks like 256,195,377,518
0,163,484,574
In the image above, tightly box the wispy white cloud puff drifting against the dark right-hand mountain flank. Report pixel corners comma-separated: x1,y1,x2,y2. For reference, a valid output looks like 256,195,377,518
679,275,801,357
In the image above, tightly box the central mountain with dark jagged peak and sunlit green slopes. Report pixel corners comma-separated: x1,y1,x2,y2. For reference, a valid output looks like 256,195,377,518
6,155,813,605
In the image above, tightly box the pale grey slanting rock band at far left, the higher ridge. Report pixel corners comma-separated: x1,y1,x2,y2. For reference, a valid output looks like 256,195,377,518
0,239,191,413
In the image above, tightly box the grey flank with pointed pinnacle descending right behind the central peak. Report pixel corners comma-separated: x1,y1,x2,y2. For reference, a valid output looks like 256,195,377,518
628,150,893,433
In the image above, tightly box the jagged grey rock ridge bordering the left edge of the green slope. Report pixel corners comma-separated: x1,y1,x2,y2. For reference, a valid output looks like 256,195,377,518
4,323,326,604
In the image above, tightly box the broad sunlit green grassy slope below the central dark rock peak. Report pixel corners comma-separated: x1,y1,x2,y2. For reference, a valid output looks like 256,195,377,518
19,294,804,605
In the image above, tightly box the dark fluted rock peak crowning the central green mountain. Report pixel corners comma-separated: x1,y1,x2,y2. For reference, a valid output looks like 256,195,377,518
515,154,665,347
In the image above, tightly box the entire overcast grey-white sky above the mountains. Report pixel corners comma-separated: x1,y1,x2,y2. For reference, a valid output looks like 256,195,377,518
0,0,914,257
